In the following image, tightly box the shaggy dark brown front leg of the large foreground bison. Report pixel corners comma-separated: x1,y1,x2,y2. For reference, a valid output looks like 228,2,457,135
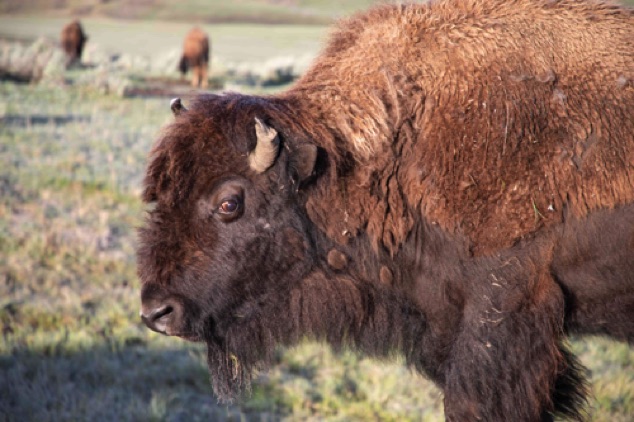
445,275,584,422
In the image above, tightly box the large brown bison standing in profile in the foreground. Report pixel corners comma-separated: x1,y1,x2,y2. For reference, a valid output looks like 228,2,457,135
138,0,634,421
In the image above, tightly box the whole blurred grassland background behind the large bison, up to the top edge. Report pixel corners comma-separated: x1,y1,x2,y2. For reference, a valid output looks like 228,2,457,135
0,0,634,422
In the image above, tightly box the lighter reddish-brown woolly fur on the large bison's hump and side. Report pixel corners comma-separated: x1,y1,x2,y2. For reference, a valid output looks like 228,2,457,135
289,1,634,254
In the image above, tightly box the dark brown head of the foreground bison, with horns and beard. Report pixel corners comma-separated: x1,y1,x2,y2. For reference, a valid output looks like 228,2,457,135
137,95,317,398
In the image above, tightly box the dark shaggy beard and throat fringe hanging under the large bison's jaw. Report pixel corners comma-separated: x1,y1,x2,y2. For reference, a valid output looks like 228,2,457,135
202,275,432,401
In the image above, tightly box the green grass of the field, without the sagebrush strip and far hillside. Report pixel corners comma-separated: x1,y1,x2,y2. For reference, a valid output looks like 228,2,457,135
0,4,634,422
